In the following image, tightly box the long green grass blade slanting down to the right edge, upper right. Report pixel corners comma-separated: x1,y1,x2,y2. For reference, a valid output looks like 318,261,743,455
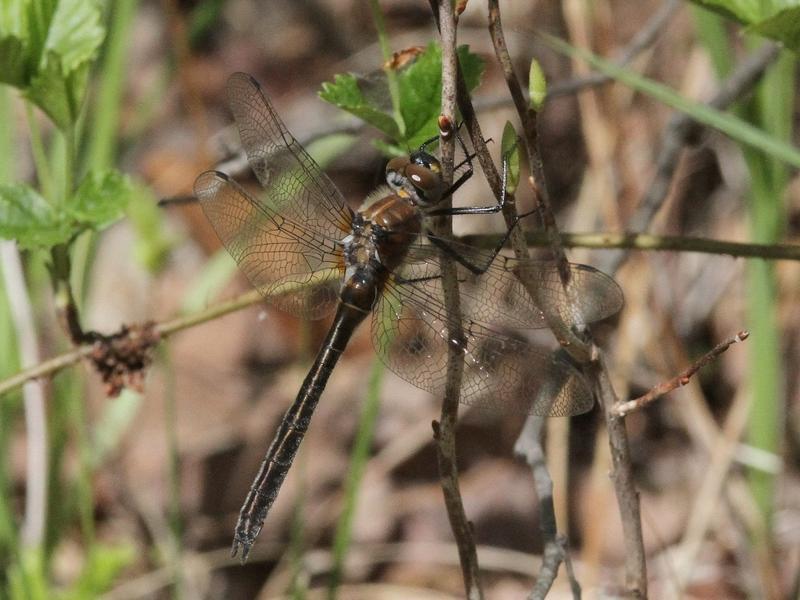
537,32,800,167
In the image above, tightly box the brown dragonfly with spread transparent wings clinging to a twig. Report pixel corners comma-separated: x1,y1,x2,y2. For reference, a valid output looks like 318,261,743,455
194,73,623,562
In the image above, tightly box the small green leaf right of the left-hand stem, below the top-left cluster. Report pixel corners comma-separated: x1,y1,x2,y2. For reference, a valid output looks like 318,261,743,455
66,170,135,230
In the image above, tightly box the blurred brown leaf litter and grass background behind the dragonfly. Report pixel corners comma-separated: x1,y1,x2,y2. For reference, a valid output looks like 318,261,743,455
0,0,800,600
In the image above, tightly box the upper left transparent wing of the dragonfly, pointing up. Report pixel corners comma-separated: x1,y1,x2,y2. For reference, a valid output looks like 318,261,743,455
227,73,352,239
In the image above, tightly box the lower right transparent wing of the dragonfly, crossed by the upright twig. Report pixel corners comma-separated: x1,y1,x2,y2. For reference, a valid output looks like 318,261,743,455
372,280,593,416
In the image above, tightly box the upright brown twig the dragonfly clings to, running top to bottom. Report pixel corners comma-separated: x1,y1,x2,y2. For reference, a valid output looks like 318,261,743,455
431,0,483,600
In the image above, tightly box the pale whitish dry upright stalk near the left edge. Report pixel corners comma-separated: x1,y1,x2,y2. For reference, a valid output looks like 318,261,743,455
0,241,47,548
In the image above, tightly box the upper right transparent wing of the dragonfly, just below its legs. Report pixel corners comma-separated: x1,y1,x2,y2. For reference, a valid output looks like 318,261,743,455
404,236,623,329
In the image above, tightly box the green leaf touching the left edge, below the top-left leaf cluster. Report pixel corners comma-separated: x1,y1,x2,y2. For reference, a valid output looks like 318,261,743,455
0,184,70,249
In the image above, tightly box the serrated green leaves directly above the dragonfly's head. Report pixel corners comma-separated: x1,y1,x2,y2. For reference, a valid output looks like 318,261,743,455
319,43,484,153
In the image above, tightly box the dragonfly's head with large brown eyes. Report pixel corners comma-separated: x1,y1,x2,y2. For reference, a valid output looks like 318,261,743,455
386,150,444,208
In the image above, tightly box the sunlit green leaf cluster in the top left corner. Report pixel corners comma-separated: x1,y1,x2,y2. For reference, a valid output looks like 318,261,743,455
0,0,105,130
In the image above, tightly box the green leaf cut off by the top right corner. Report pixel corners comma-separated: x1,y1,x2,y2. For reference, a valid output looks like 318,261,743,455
692,0,800,52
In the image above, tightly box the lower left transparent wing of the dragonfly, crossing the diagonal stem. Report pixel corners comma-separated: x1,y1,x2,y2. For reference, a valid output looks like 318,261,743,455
194,171,343,319
